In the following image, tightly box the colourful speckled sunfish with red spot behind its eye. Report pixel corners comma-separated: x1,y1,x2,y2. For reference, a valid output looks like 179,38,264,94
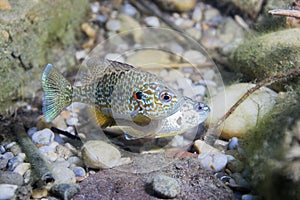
42,57,185,128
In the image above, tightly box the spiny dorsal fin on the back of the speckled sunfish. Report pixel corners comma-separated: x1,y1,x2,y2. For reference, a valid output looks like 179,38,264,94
80,57,137,84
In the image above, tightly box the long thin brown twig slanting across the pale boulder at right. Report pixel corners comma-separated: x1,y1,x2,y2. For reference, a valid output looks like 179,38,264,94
204,67,300,144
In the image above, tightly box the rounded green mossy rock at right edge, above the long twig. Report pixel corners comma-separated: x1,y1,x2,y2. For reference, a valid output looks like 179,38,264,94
230,29,300,91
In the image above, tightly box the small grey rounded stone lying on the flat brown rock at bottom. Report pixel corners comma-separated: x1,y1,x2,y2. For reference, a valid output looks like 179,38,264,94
152,174,180,198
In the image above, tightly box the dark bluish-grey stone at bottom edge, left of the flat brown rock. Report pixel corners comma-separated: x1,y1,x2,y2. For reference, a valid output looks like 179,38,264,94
51,184,80,199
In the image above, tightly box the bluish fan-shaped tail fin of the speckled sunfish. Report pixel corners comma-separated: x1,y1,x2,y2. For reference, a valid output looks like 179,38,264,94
42,64,73,122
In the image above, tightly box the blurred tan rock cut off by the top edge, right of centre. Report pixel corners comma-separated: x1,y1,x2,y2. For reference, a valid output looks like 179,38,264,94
156,0,196,12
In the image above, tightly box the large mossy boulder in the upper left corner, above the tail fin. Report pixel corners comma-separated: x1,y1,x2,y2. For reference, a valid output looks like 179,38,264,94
0,0,89,113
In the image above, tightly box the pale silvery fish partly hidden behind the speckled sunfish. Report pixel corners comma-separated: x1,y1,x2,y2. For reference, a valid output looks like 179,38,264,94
106,97,210,140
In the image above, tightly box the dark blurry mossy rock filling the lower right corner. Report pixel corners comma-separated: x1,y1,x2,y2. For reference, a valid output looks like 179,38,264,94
243,86,300,200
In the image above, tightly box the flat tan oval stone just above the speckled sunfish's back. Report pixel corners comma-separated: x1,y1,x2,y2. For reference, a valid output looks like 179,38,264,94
126,49,171,69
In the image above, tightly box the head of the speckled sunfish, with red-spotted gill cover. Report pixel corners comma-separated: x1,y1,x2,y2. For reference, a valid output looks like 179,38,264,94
133,83,183,120
